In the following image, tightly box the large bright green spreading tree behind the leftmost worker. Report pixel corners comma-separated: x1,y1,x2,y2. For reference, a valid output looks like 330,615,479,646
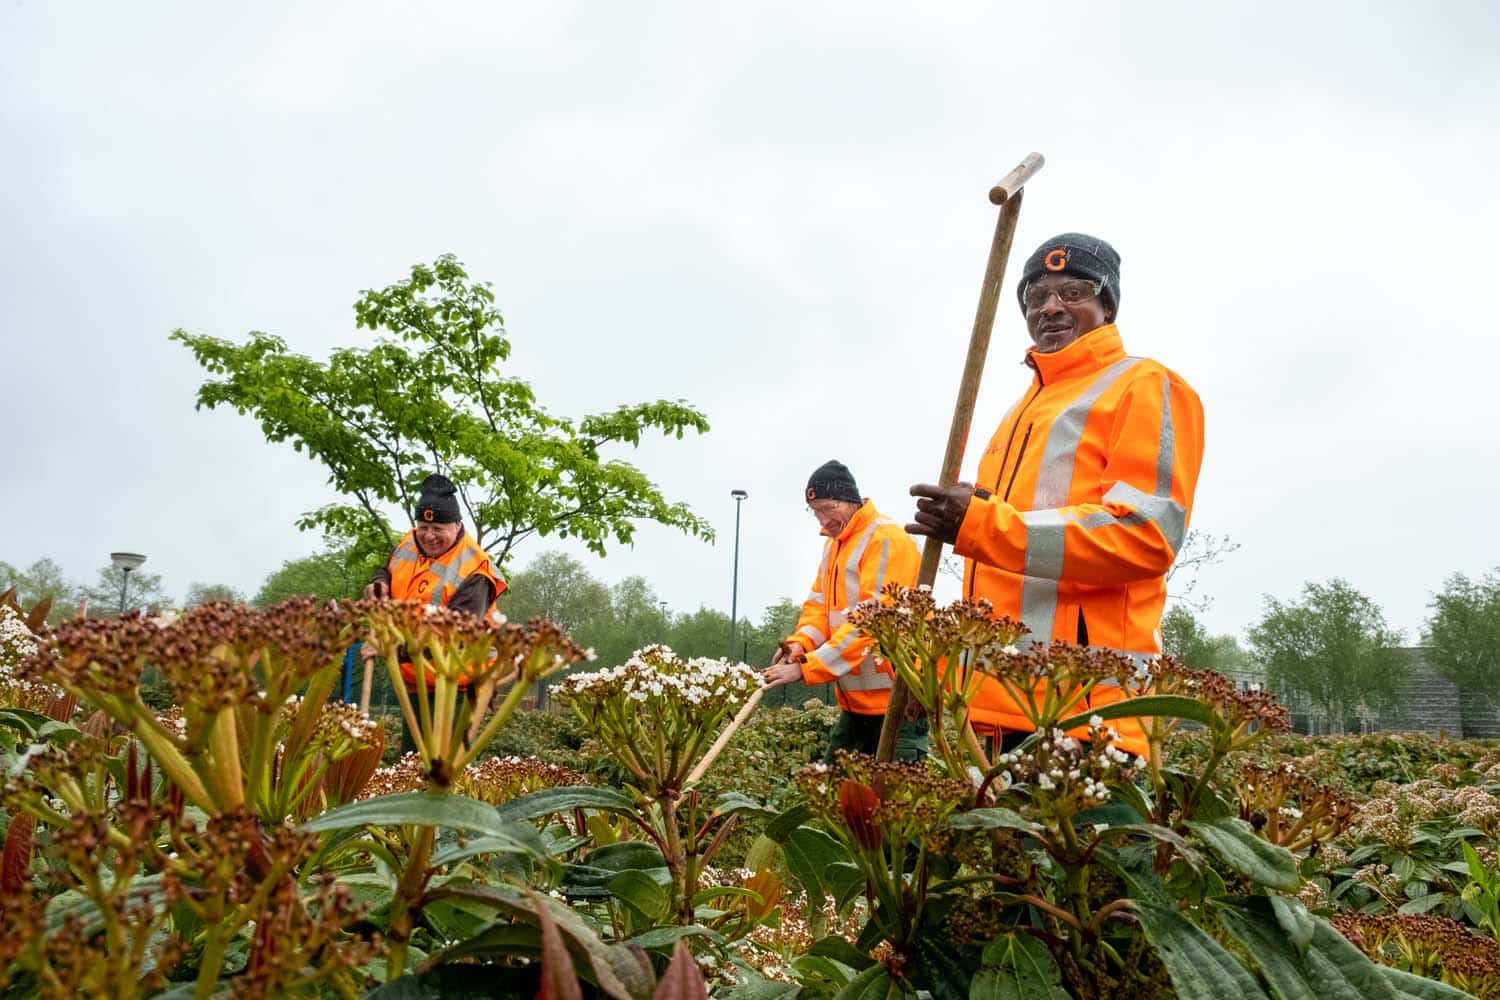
173,255,713,565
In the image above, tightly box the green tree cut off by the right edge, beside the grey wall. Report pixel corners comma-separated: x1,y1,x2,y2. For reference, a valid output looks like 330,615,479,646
1422,570,1500,700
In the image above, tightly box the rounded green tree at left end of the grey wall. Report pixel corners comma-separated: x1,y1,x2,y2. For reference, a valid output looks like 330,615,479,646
1250,579,1410,724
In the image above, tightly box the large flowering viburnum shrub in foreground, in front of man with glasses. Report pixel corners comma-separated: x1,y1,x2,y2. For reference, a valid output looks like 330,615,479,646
750,586,1464,1000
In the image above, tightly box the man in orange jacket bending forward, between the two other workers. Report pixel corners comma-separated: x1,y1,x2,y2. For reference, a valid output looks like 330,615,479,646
764,462,927,763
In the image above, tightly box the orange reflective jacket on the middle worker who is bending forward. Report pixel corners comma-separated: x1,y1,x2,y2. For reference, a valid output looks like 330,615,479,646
788,501,921,715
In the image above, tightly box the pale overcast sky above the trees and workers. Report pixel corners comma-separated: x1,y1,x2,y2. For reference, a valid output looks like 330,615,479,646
0,0,1500,637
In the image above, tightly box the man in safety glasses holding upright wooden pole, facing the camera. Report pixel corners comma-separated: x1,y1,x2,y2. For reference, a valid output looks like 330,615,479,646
908,232,1203,754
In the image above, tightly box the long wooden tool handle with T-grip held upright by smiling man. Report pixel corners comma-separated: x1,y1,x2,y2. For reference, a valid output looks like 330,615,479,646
876,153,1044,760
